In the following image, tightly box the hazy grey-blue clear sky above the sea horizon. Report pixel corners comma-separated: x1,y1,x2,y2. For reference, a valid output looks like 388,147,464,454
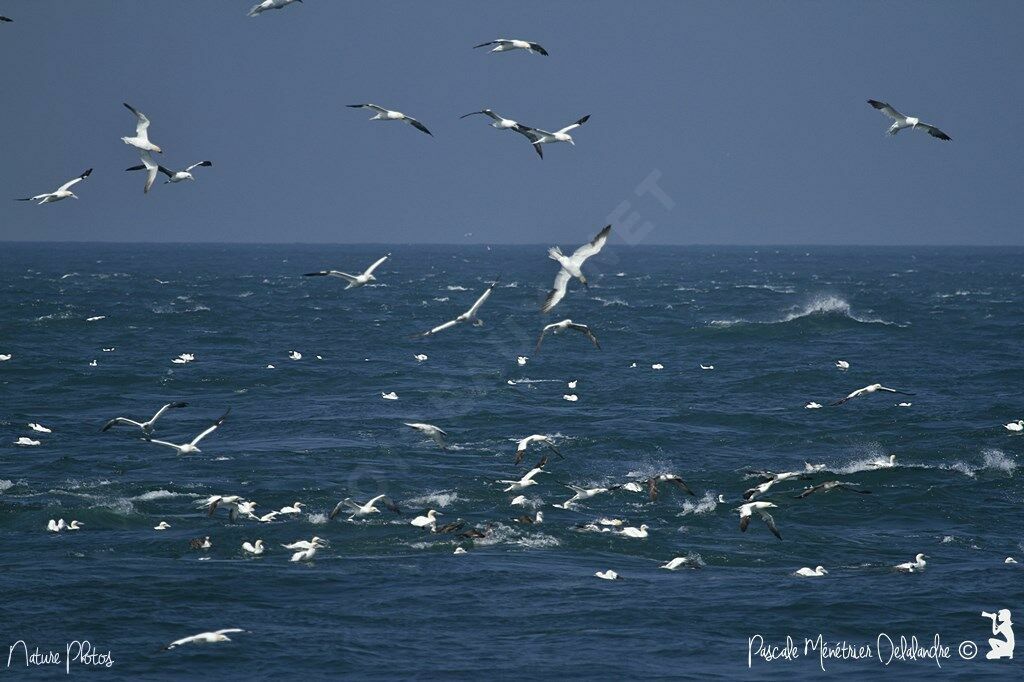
0,0,1024,245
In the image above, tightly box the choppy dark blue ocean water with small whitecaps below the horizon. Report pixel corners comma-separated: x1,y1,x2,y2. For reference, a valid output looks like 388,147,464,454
0,243,1024,679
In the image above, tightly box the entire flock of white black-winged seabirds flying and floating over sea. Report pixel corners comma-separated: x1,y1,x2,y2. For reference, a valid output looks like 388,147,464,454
0,0,1007,649
